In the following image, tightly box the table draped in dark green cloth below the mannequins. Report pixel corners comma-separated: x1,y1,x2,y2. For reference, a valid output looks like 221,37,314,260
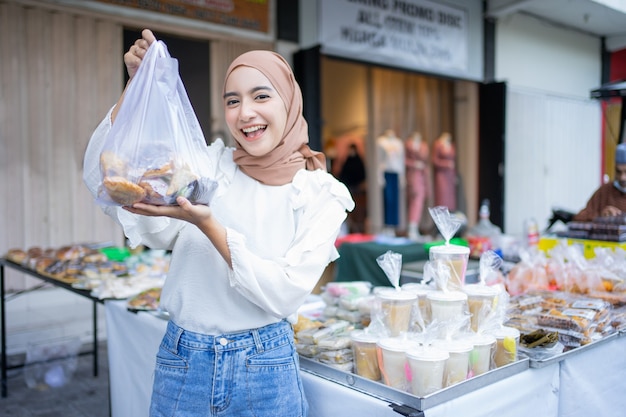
335,237,428,286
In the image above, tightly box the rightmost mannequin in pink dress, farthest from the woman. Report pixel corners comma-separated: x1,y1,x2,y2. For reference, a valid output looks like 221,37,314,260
432,132,456,212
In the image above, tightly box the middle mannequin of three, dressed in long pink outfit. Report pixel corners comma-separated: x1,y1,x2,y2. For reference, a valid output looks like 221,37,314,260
404,132,429,240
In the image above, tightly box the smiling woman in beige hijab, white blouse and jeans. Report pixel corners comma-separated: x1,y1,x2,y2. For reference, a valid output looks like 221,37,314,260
83,29,354,417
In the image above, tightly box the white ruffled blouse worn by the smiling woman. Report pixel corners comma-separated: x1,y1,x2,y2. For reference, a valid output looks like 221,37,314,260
83,112,354,335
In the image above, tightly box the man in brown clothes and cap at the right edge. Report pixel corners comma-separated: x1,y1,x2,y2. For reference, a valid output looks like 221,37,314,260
573,143,626,222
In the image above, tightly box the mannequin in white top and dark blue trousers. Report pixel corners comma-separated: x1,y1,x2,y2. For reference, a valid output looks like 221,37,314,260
376,129,404,234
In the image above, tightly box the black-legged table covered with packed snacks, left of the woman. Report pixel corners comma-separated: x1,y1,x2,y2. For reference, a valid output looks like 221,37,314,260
0,244,169,397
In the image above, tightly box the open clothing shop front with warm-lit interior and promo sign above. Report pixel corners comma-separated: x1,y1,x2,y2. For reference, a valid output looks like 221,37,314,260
294,1,483,235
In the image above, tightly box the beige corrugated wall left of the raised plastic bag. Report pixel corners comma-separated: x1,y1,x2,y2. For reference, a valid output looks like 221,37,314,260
0,2,123,291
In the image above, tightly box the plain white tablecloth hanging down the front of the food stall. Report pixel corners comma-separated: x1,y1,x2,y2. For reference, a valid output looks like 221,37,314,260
105,301,626,417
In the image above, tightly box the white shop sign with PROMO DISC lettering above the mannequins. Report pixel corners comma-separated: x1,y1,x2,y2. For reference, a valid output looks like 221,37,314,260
319,0,468,74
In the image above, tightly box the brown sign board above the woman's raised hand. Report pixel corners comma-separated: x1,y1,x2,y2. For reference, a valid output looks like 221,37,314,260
98,0,270,33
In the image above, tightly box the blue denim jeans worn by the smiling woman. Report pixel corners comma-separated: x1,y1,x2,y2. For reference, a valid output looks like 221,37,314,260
150,321,308,417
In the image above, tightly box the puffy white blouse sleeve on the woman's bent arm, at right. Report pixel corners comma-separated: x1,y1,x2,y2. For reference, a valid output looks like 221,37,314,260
227,170,354,319
